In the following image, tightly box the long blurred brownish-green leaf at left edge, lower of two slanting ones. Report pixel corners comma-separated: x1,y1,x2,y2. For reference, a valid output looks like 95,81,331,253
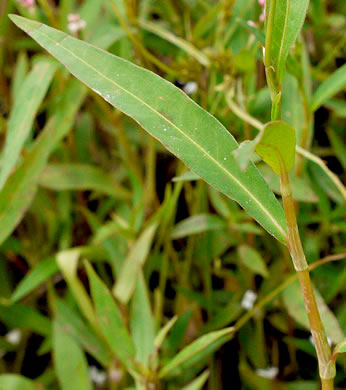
0,80,86,244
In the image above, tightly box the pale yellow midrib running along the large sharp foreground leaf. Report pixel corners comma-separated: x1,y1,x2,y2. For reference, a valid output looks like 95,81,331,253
30,24,286,238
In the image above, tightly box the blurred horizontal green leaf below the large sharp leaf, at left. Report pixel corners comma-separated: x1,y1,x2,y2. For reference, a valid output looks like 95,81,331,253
40,164,131,200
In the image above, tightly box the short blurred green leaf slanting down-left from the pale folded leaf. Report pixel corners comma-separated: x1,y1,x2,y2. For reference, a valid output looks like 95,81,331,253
11,257,59,302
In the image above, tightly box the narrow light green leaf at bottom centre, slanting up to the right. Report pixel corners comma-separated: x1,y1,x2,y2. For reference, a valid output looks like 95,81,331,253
159,328,233,378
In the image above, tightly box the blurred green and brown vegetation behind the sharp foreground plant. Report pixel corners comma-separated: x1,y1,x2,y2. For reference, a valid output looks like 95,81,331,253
0,0,346,390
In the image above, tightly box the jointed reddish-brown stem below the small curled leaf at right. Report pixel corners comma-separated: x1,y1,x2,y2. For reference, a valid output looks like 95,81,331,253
280,167,335,390
